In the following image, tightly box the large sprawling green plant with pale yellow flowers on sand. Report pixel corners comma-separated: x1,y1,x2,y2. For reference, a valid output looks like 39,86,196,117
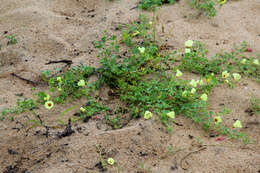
1,16,260,142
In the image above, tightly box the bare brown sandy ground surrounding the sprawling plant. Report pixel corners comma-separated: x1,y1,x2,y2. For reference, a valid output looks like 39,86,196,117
0,0,260,173
